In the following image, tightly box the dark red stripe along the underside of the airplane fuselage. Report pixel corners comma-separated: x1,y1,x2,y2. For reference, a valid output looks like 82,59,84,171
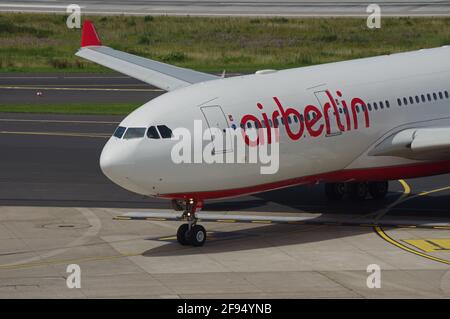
158,161,450,201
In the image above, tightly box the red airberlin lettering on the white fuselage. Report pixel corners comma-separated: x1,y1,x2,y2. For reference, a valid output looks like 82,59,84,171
241,90,370,146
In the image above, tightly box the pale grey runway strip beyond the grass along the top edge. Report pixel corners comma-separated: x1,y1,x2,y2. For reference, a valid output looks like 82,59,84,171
0,0,450,16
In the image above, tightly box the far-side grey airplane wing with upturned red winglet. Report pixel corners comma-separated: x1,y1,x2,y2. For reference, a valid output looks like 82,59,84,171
75,20,220,91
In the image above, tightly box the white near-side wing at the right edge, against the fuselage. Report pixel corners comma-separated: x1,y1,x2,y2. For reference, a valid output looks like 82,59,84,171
369,127,450,160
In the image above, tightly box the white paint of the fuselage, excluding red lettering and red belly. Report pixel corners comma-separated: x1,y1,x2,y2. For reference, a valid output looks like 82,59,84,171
101,47,450,200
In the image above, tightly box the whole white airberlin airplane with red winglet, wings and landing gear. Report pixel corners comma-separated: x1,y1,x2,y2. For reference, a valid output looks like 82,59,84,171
76,21,450,246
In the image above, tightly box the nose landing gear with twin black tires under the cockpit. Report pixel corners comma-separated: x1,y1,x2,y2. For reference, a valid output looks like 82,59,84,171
177,199,206,247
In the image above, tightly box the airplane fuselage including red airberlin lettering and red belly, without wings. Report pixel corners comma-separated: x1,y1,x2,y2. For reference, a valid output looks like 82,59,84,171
100,47,450,200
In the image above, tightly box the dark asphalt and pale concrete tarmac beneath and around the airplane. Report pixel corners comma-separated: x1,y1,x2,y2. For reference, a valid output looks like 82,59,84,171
0,74,450,298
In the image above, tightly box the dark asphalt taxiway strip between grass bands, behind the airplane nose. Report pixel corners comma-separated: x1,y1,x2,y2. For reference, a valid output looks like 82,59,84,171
0,73,164,106
